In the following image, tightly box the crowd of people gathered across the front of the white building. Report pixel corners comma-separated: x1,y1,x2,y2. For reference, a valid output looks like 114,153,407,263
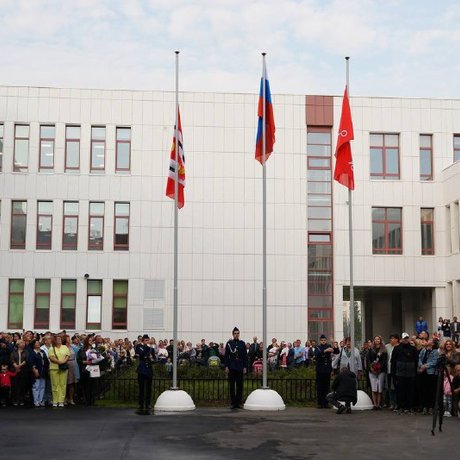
0,317,460,416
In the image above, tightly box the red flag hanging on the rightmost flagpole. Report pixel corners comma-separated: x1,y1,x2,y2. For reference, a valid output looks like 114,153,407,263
334,86,355,190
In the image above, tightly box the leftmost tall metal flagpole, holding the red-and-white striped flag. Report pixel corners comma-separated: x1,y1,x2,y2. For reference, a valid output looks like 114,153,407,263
171,51,179,390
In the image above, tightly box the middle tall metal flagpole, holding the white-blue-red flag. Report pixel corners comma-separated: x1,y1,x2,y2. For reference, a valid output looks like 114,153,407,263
262,53,268,388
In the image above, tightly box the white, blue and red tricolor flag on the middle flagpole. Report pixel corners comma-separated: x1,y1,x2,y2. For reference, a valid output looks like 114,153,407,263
256,61,275,164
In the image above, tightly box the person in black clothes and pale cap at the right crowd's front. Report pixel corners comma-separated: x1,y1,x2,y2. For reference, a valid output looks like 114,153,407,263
391,332,418,414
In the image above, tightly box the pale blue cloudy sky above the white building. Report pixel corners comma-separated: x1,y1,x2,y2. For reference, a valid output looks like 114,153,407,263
0,0,460,98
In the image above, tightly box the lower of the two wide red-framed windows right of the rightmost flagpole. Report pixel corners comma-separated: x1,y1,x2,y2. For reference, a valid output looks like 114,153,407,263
372,208,402,254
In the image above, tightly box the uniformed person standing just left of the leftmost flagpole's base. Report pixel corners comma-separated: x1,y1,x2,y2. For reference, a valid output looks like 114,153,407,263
135,334,155,415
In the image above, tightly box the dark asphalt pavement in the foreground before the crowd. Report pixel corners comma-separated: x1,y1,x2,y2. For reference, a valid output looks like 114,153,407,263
0,407,460,460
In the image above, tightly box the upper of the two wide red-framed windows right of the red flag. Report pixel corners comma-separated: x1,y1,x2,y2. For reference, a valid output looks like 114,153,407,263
370,134,399,180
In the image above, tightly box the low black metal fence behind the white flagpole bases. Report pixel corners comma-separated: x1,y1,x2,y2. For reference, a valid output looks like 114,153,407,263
97,376,368,405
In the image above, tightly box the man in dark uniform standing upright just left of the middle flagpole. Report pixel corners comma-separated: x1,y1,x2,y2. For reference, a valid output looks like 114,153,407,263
224,327,248,409
